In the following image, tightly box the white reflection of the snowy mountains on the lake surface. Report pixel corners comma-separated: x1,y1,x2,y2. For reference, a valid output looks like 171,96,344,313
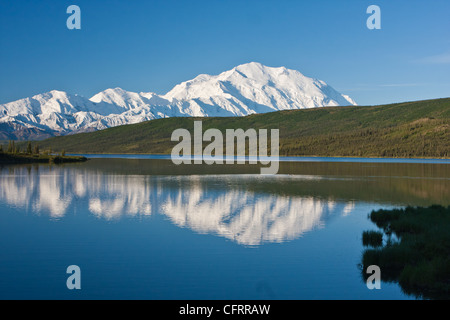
0,166,353,245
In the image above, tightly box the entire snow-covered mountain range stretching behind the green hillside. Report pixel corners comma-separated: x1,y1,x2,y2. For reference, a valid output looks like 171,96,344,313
0,62,356,140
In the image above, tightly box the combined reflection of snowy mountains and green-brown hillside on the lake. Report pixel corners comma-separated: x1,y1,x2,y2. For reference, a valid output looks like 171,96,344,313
0,159,450,245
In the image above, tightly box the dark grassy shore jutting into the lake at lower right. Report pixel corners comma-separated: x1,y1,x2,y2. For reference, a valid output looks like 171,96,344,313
361,205,450,299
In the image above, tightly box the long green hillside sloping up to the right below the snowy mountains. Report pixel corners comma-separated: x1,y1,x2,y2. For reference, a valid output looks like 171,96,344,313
33,98,450,158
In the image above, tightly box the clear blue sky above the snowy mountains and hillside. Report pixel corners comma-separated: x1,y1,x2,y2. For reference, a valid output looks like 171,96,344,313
0,0,450,105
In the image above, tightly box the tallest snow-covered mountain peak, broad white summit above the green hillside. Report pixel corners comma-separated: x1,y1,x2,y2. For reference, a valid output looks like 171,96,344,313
165,62,355,110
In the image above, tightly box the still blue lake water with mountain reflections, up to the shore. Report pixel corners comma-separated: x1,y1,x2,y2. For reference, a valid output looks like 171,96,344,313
0,156,450,300
